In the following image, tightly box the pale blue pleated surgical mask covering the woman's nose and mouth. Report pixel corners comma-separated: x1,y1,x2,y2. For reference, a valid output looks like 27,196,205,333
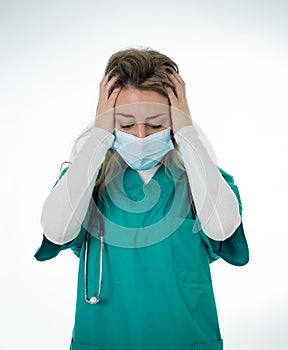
112,128,174,170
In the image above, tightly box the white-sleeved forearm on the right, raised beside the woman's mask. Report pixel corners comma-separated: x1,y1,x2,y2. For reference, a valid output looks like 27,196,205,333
175,125,241,241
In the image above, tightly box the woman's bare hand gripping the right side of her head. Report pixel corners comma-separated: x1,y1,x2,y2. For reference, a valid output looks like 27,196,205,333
166,71,192,134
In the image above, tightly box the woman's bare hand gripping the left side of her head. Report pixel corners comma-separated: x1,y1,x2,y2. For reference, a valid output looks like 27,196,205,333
94,74,121,133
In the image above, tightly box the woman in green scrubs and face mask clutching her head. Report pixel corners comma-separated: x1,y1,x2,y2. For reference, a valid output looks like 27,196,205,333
35,49,249,350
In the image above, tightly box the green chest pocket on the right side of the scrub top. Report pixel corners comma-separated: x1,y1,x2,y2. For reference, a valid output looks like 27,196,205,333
173,219,211,284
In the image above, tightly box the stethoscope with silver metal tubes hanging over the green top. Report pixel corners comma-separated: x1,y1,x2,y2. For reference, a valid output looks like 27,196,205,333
59,161,104,305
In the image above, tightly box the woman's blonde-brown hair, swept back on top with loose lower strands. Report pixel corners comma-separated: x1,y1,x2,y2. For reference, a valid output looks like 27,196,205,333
72,48,184,200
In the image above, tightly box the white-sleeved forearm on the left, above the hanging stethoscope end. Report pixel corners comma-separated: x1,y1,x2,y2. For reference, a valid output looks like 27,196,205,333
41,128,114,244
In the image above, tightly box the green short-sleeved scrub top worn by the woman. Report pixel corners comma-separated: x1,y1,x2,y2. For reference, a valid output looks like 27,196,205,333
35,165,249,350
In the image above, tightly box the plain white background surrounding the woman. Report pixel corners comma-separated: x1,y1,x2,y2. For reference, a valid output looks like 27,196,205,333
0,0,288,350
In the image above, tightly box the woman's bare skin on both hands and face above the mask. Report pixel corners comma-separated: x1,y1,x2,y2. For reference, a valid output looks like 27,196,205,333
95,71,192,134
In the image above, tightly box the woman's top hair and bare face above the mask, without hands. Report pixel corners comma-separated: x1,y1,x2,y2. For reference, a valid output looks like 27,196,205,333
105,49,178,138
